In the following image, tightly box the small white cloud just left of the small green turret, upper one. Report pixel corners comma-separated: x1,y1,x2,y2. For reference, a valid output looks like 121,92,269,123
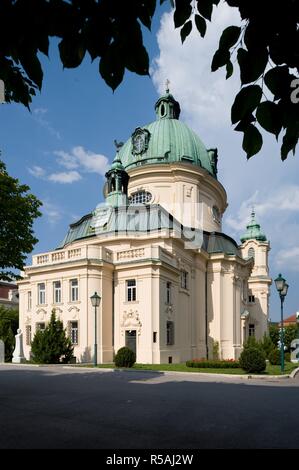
54,146,109,176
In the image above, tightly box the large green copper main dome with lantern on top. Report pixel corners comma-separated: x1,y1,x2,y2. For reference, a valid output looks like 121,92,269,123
119,90,217,177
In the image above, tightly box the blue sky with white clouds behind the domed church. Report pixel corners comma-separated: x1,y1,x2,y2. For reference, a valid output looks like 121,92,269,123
0,1,299,320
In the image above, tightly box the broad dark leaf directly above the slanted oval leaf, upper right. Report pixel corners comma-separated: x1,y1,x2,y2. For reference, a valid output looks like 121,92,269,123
238,48,268,85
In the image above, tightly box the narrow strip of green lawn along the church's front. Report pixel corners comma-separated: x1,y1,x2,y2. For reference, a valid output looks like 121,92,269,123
89,362,298,375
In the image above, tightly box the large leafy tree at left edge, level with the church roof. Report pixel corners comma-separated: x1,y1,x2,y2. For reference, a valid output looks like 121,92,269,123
0,161,41,280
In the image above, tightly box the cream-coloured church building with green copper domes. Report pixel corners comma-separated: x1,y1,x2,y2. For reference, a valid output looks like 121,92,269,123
19,90,271,364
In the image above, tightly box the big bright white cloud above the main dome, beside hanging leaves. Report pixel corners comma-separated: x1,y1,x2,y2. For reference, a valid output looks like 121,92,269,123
151,3,241,130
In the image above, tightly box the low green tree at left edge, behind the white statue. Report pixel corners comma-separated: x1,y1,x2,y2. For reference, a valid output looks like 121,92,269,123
0,305,19,362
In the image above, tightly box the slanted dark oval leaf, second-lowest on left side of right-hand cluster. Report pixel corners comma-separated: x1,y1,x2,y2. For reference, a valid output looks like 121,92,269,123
231,85,263,124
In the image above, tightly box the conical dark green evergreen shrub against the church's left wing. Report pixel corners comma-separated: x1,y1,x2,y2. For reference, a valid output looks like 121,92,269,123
31,311,74,364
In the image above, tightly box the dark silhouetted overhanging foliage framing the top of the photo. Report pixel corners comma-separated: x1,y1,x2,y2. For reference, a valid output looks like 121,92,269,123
0,0,299,160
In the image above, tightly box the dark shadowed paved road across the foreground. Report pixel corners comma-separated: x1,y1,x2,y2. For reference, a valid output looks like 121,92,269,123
0,365,299,449
